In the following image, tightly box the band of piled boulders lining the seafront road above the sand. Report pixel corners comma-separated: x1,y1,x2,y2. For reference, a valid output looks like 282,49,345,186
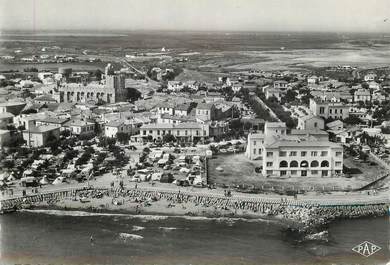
1,186,388,227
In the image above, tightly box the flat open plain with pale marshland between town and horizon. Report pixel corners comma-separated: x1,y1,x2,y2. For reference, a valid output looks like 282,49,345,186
0,31,390,75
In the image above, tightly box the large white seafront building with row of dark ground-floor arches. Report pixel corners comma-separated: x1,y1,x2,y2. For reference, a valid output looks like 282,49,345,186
246,122,343,177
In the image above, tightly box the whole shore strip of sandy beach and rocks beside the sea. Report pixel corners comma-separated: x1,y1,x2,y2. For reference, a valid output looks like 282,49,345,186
1,188,388,234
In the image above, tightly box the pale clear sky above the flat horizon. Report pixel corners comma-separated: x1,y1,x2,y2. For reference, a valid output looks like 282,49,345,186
0,0,390,32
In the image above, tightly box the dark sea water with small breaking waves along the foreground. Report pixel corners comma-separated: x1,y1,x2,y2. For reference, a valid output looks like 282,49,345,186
0,211,390,264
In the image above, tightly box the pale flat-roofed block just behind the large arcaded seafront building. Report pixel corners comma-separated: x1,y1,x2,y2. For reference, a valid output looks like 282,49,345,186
310,98,349,120
